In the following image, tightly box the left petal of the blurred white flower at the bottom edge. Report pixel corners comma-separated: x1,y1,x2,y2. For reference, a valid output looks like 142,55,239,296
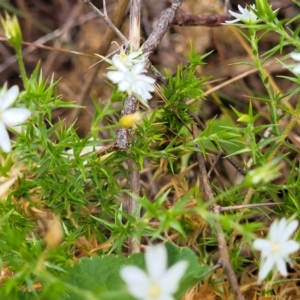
120,266,150,299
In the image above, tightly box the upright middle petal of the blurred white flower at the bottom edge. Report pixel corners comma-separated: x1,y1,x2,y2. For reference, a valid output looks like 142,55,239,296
145,245,167,279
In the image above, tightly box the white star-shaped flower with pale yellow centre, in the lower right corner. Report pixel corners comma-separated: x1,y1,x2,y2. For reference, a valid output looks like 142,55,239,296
253,218,300,281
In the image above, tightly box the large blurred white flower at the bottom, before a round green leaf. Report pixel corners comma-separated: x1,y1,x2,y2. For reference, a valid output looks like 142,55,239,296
120,245,188,300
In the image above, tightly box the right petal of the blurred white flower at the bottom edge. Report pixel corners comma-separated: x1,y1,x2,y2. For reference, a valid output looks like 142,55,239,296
162,261,188,294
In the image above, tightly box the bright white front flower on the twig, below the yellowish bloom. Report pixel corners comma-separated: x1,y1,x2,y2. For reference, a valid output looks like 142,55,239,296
107,55,155,102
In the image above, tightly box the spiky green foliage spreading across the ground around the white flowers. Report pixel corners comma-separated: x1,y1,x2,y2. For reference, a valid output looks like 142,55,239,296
0,0,300,300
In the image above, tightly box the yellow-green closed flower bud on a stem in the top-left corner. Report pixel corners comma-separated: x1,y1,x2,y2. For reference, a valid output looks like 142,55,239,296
1,13,22,48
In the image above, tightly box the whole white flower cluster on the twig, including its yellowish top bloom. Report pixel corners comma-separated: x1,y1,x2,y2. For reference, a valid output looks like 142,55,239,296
101,49,155,103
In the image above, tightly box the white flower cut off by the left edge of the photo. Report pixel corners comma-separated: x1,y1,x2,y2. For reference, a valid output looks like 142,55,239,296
0,85,31,152
